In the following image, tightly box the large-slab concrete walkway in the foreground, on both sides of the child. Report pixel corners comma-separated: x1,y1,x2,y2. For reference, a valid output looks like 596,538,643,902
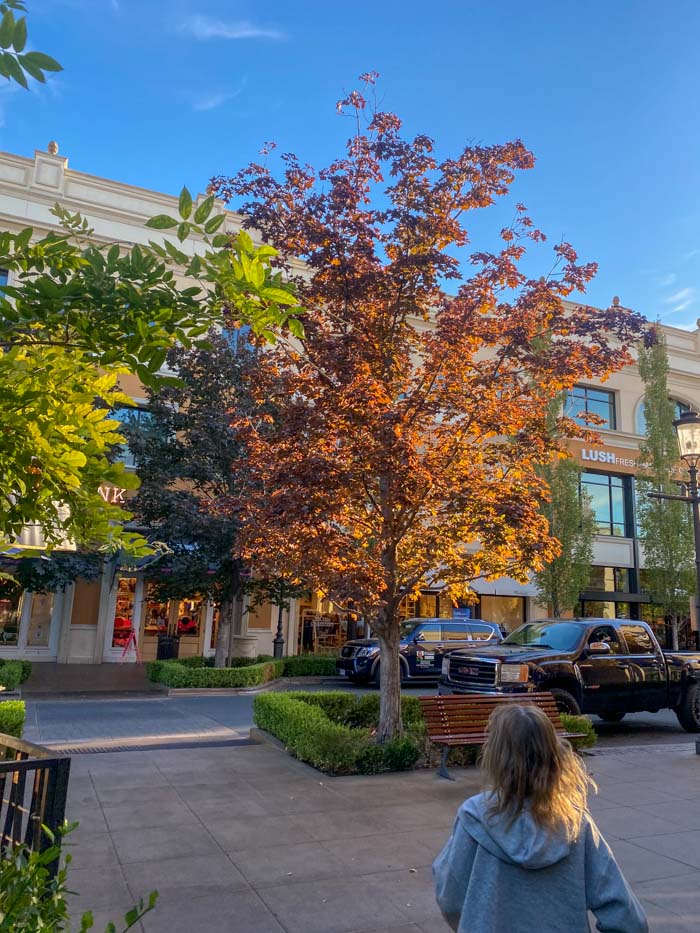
61,745,700,933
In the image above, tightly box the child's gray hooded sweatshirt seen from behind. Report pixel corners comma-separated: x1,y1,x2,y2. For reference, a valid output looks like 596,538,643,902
433,794,649,933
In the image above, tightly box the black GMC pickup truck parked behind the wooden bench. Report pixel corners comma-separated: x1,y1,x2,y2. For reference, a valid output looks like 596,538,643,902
439,619,700,732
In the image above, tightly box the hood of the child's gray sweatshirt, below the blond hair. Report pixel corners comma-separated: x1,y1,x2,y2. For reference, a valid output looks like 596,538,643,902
459,794,571,869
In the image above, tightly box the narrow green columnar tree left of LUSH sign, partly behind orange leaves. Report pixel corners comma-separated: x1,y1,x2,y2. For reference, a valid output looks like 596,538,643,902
534,396,595,619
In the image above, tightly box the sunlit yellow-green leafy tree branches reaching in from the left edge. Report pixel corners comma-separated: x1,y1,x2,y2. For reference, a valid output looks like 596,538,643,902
0,196,302,553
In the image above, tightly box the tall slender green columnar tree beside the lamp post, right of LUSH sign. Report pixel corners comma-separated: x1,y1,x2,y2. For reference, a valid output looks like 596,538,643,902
637,332,695,648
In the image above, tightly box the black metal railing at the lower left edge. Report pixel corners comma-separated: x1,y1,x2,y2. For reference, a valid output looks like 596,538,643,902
0,733,70,875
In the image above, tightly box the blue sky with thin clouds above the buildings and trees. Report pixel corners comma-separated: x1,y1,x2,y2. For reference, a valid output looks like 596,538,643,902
5,0,700,327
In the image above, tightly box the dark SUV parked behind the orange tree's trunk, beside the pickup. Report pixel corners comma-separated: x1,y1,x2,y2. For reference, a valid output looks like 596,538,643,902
335,619,501,684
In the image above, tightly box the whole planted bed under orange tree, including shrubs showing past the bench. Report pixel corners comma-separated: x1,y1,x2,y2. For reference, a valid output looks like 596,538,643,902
253,691,595,774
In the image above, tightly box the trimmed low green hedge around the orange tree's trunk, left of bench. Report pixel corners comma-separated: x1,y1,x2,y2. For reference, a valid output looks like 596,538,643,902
253,691,421,774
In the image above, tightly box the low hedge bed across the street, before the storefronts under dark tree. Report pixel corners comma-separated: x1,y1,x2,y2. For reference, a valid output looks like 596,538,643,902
146,654,335,689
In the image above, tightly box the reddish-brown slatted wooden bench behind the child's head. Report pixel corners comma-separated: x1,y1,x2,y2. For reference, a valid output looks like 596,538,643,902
419,693,582,781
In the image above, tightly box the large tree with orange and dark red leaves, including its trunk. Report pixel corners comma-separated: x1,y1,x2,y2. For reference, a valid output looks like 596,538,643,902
214,75,644,741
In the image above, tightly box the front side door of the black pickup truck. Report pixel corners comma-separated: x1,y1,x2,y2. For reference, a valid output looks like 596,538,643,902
578,625,636,713
